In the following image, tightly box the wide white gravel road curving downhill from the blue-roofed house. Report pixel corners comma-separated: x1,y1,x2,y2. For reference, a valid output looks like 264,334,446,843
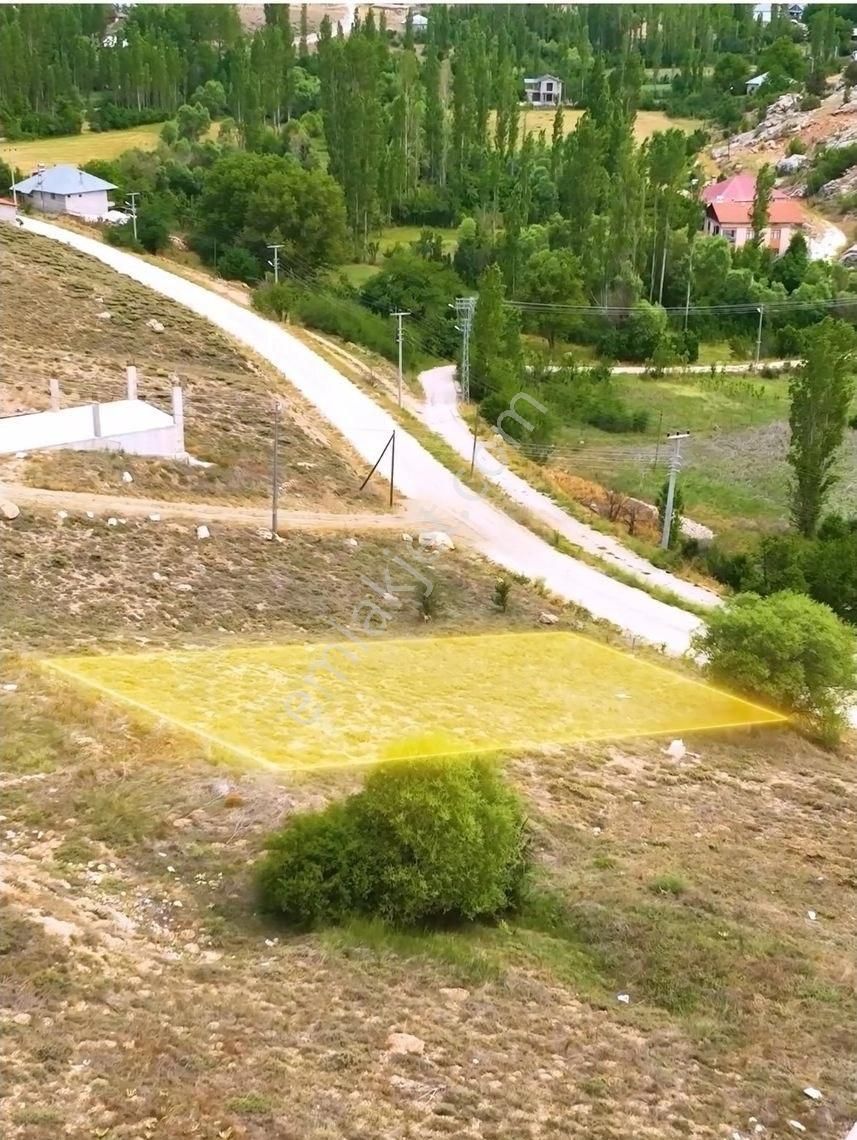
24,218,701,654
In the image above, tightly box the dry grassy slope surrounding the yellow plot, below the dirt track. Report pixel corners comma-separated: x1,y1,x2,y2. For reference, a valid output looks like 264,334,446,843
0,513,857,1140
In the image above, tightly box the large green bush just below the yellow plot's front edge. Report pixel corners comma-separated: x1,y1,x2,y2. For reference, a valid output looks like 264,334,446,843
259,758,528,927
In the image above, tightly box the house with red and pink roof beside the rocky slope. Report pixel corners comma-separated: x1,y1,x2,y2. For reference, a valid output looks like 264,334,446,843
701,171,807,255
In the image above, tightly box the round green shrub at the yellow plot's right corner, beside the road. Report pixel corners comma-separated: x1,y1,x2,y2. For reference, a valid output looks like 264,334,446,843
694,591,857,742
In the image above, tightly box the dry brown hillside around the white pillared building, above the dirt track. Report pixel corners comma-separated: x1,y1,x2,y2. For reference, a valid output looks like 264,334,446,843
0,226,383,511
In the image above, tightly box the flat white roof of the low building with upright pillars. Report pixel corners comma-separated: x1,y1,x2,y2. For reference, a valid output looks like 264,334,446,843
0,400,173,455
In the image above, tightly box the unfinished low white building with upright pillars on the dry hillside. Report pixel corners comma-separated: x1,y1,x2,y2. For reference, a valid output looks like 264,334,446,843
0,368,188,459
